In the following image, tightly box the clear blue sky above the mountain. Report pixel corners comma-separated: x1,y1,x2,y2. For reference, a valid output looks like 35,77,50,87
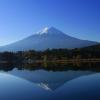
0,0,100,46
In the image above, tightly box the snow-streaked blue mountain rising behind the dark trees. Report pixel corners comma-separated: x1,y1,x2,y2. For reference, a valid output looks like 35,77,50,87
0,27,98,51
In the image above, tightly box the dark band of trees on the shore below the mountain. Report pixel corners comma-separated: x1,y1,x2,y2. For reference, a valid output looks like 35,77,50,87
0,45,100,63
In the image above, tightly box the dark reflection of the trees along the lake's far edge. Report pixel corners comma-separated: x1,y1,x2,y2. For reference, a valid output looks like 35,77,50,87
0,62,100,72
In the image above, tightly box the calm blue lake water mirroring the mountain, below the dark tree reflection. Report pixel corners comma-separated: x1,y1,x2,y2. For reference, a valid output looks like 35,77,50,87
0,63,100,100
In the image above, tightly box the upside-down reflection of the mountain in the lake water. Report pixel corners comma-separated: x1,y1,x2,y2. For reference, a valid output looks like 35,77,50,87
9,69,92,90
